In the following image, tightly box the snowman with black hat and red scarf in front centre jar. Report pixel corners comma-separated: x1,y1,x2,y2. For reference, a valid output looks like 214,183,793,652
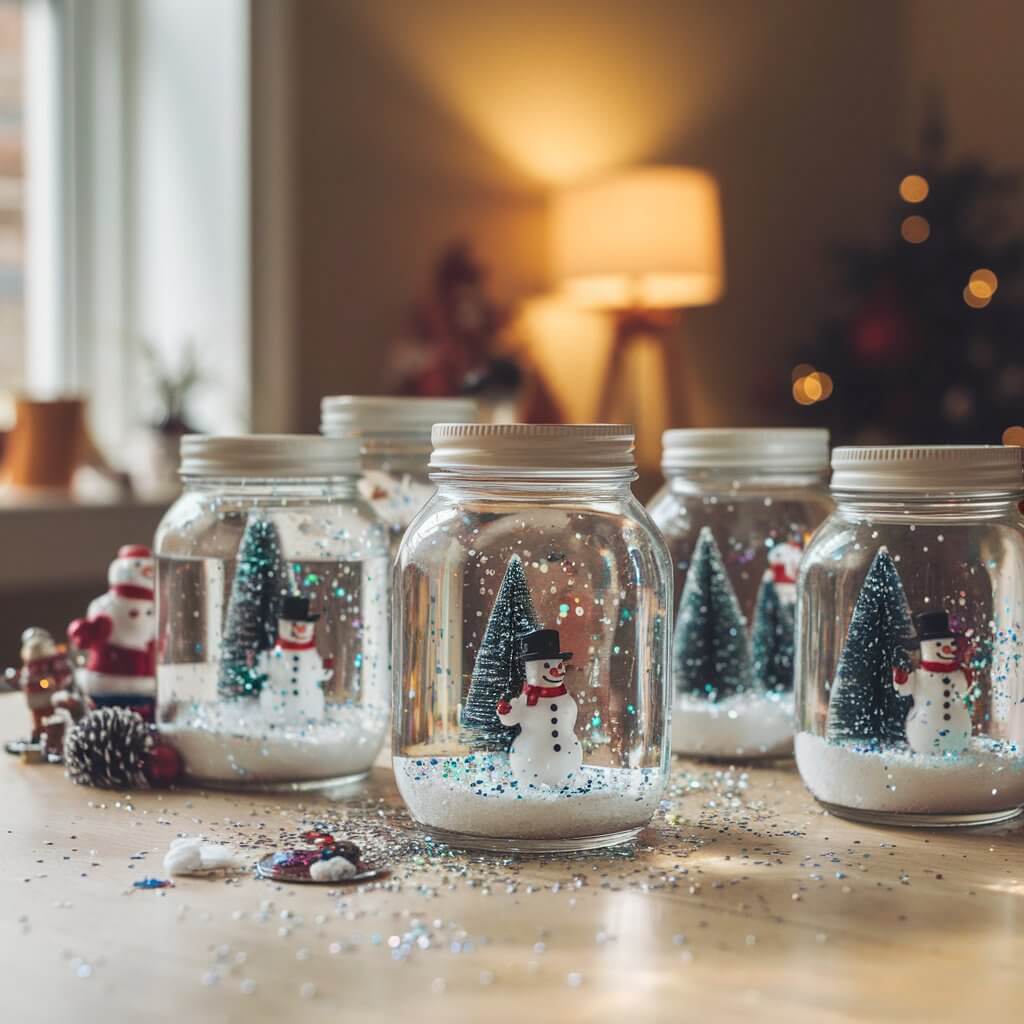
498,630,583,786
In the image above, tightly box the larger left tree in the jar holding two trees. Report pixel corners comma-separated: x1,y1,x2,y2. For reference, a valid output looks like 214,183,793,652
672,526,751,700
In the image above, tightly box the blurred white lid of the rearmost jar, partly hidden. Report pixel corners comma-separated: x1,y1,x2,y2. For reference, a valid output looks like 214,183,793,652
321,394,478,442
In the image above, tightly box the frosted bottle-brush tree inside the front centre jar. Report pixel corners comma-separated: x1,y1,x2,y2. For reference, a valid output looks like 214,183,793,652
462,555,539,751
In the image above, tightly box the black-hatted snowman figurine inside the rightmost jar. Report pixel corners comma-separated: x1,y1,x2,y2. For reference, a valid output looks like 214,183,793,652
893,611,973,755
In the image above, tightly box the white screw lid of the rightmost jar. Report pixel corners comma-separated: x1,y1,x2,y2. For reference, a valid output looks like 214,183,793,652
831,444,1024,495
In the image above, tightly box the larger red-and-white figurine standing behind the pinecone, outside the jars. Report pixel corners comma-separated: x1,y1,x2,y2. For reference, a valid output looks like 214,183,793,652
68,544,157,721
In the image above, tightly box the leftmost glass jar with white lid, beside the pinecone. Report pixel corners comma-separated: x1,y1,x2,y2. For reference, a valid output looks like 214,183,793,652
156,435,390,788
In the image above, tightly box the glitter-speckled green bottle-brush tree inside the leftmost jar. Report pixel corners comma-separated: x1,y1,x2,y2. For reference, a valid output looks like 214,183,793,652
217,516,285,697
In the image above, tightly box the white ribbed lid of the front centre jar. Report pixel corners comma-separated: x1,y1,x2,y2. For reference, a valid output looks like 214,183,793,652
430,423,635,473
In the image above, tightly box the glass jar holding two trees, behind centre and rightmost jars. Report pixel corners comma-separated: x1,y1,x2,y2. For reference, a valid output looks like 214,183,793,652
649,428,831,759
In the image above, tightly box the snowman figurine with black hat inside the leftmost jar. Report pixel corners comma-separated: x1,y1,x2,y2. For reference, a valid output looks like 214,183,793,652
258,596,334,725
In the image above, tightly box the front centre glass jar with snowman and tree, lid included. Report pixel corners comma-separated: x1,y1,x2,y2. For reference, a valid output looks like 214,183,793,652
392,424,672,851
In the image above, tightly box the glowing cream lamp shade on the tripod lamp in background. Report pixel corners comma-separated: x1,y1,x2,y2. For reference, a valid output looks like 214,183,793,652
552,167,725,309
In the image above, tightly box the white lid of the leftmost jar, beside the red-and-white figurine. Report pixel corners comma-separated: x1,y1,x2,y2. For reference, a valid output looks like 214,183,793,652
180,434,359,479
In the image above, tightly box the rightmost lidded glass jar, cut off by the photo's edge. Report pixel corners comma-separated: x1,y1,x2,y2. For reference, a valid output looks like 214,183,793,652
796,446,1024,825
